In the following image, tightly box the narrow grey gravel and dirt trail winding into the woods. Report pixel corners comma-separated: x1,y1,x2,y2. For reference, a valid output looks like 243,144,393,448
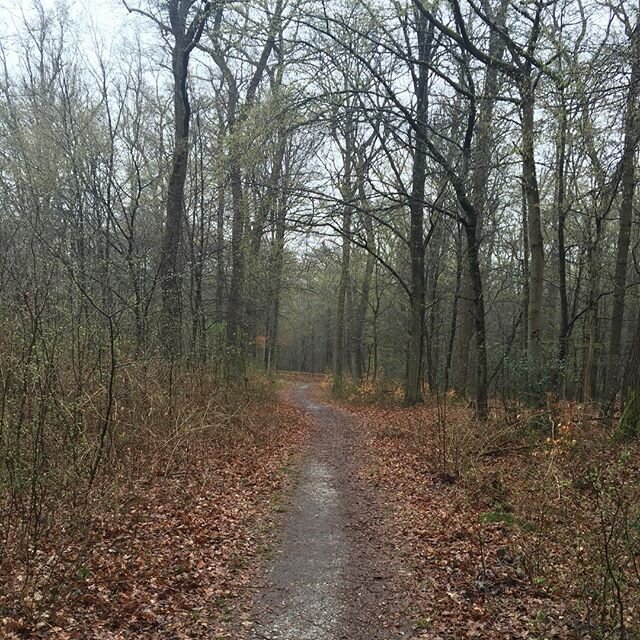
247,383,411,640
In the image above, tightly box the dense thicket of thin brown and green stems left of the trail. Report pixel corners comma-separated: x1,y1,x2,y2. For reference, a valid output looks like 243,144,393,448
0,343,274,617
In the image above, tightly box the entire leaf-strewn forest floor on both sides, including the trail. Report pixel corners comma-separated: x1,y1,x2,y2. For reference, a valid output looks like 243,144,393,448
0,378,640,640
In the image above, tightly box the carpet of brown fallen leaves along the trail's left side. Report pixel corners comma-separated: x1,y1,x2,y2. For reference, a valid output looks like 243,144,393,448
0,402,305,640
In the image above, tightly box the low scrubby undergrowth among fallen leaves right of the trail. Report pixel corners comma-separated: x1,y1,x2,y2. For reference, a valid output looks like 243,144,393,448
349,388,640,639
